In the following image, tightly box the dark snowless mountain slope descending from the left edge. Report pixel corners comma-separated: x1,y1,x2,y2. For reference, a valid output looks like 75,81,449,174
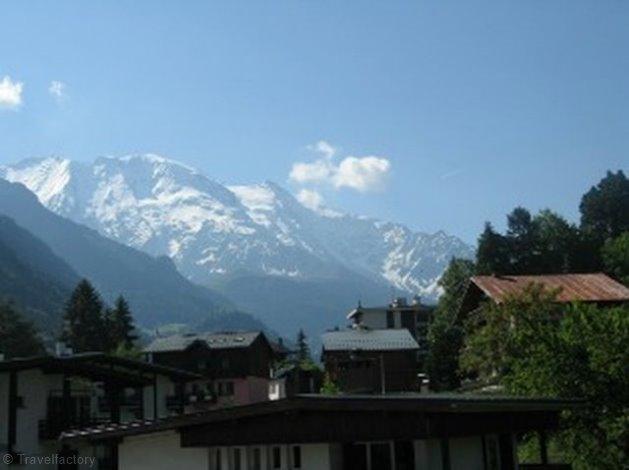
0,180,263,329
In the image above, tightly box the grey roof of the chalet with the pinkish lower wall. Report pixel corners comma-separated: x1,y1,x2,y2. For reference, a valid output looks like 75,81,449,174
144,331,262,352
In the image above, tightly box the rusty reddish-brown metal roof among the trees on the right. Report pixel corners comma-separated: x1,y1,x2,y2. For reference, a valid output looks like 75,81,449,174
470,273,629,302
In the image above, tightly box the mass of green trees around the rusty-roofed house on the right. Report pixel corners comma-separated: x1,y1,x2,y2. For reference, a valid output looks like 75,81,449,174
427,171,629,469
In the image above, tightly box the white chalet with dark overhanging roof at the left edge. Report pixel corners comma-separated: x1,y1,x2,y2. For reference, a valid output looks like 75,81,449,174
0,353,200,469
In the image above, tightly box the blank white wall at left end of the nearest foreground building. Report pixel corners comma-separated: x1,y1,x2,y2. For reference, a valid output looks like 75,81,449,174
118,431,210,470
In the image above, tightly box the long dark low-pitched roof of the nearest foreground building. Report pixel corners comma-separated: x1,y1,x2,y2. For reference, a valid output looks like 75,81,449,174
61,394,580,442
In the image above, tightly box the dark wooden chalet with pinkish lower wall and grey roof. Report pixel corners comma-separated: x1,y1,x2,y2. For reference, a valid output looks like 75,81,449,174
144,331,277,411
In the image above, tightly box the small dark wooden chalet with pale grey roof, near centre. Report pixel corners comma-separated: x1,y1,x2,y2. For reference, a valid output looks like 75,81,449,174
321,325,420,393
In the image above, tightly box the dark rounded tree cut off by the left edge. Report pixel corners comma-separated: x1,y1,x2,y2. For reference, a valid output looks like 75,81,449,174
0,302,45,359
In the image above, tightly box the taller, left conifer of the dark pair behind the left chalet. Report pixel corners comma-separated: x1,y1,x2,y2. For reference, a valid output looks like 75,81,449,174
61,279,108,352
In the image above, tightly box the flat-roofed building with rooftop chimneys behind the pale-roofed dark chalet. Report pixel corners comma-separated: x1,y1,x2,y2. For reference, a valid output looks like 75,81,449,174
347,296,434,353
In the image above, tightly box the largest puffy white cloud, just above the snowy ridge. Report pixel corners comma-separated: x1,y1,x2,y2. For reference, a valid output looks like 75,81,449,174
289,140,391,192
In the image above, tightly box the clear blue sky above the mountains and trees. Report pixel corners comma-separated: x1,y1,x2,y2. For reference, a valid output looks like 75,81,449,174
0,0,629,242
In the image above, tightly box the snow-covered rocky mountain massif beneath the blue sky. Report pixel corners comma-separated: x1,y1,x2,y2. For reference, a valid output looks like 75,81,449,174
0,155,472,301
